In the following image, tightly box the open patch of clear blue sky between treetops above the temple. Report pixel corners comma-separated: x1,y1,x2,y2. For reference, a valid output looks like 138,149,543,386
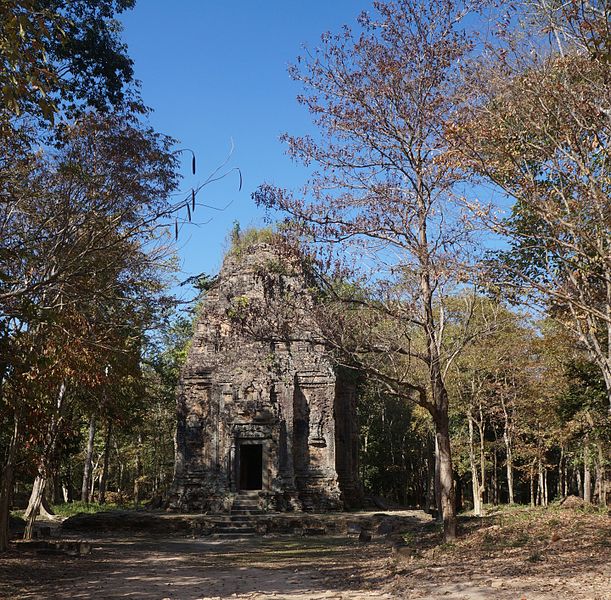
121,0,370,290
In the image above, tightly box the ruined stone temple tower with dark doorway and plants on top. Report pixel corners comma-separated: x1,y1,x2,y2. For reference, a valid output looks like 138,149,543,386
170,241,360,512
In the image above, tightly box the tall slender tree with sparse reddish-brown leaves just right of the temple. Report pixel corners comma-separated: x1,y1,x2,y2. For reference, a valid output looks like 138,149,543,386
254,0,488,540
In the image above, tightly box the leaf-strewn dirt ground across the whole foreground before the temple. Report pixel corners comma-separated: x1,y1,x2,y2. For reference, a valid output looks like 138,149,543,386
0,511,611,600
